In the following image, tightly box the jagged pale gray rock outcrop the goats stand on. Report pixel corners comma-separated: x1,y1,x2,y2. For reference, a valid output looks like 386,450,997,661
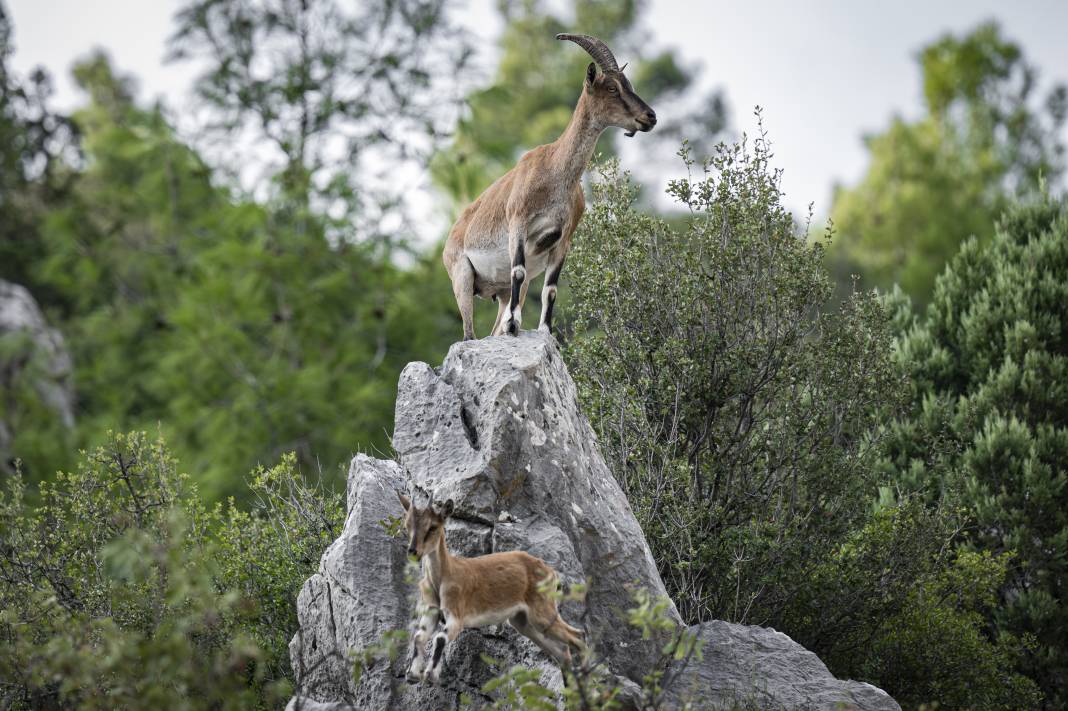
290,333,898,710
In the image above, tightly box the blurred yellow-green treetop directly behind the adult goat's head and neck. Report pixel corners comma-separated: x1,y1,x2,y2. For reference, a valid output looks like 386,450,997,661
431,0,725,208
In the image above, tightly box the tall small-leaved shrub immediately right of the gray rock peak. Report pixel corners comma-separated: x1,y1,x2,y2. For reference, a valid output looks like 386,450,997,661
567,123,892,621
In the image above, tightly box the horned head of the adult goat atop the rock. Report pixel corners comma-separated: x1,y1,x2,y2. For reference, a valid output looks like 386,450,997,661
556,33,657,137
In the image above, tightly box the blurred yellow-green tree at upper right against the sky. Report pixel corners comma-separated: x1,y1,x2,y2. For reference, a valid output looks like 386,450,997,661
831,22,1068,303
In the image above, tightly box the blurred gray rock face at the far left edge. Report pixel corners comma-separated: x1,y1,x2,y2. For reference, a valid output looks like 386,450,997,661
0,279,74,471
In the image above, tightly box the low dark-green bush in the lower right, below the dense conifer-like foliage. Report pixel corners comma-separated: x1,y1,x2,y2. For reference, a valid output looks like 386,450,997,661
784,496,1041,710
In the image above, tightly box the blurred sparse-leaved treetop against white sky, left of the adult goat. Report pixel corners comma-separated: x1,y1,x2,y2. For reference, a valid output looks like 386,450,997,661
170,0,469,242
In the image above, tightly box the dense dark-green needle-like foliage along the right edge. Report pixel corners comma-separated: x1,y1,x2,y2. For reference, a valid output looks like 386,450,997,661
884,192,1068,709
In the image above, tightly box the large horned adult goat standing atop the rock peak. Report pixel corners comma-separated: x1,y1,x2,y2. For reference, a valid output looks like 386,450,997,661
442,34,657,341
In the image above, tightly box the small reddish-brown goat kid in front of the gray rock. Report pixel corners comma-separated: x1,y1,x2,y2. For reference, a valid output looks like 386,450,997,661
397,493,585,683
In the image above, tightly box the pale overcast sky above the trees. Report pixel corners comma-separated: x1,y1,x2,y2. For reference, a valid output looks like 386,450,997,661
8,0,1068,224
